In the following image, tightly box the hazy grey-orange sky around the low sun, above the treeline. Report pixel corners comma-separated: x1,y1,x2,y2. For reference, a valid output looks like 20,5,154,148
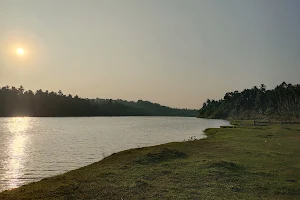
0,0,300,108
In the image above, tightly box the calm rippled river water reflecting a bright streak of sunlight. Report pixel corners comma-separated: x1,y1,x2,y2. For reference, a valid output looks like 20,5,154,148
0,117,229,191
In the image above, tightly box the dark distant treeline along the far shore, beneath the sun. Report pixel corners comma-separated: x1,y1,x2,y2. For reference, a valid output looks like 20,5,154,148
0,86,197,117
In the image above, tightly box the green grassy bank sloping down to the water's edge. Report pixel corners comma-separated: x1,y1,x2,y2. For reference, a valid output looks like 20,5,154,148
0,121,300,200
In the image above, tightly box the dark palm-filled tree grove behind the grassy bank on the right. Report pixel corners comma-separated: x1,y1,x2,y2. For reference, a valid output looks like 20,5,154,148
198,82,300,119
